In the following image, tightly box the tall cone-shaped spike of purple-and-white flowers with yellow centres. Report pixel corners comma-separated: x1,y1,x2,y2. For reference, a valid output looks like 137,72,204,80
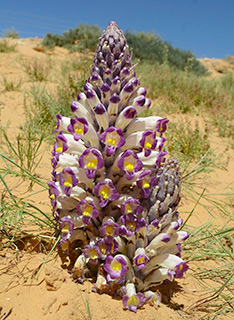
48,22,188,311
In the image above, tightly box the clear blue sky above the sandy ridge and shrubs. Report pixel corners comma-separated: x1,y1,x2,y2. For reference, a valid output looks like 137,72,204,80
0,0,234,58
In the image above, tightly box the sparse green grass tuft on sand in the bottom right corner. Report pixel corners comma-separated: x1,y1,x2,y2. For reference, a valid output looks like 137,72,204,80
183,218,234,319
